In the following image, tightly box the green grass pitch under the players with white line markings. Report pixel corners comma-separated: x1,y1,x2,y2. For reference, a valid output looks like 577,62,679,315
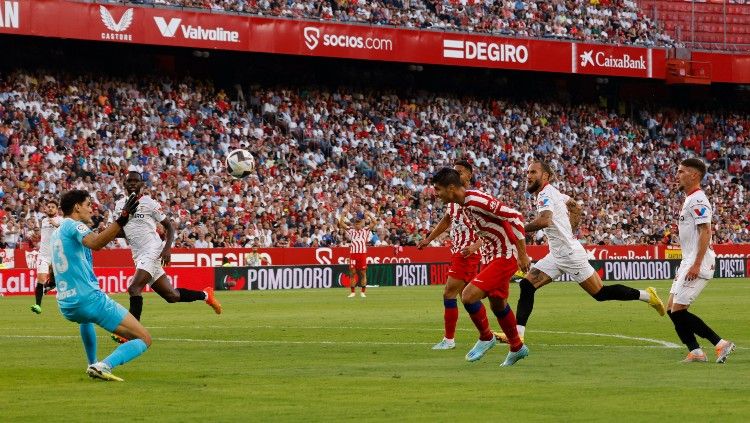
0,279,750,422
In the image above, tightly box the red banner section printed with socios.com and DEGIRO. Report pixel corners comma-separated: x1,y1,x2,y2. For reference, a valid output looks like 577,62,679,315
250,18,571,72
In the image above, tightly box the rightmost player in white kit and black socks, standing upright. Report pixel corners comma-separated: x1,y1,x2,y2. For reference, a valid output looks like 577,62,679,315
667,158,735,363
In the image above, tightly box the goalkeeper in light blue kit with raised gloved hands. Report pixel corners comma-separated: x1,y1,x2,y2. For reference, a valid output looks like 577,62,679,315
50,190,151,382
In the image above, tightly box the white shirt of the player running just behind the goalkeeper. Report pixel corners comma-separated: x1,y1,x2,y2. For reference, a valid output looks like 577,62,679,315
115,195,167,258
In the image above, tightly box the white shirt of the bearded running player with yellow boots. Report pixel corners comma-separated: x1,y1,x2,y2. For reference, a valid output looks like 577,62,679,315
536,184,585,258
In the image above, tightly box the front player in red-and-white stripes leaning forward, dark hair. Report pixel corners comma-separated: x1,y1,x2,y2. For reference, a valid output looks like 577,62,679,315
432,168,530,366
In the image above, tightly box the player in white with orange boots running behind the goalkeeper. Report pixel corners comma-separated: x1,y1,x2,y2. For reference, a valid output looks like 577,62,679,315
113,171,221,342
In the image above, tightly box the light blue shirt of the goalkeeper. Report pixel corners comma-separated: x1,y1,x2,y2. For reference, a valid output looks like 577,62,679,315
51,218,99,308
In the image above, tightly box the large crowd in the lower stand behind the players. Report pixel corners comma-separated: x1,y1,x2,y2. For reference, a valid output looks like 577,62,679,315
0,71,750,252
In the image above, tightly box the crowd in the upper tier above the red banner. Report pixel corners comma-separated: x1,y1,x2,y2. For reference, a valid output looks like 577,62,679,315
103,0,675,46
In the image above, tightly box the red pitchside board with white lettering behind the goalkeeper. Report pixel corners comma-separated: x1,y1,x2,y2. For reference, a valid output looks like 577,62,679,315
0,265,214,295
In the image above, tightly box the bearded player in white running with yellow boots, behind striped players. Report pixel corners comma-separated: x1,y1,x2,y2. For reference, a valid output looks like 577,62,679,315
500,160,664,341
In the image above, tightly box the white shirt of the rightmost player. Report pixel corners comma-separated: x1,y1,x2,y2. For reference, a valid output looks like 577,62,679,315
679,189,716,267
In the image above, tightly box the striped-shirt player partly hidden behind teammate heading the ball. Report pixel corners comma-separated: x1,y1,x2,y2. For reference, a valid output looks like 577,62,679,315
417,160,482,350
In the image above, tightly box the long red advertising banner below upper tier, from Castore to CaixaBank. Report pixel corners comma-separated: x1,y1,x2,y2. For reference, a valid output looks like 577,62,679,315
0,0,692,78
